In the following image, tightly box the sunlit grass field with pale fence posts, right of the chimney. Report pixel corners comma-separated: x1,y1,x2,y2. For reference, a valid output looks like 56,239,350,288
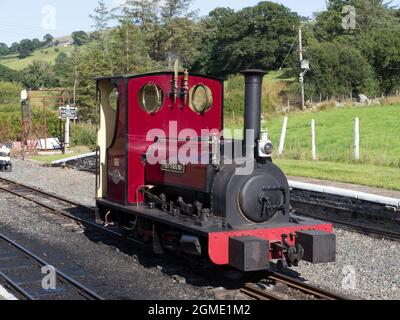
225,105,400,190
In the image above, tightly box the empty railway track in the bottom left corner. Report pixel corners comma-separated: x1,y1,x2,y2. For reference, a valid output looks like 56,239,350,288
0,234,103,300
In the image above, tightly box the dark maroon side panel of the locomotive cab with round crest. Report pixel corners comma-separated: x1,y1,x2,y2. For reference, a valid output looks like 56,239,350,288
107,80,126,204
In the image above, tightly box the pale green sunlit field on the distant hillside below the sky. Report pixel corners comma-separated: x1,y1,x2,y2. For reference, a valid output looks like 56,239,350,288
0,46,74,70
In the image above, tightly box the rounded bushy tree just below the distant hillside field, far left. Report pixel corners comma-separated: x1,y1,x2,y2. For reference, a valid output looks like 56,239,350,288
22,60,55,90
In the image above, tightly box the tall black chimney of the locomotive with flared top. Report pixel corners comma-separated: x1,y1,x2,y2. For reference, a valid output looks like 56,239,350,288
241,70,267,154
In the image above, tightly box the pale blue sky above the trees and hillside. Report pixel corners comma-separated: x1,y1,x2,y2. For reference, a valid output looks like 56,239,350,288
0,0,400,45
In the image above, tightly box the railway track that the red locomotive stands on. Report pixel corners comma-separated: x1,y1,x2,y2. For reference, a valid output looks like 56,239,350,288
0,178,347,300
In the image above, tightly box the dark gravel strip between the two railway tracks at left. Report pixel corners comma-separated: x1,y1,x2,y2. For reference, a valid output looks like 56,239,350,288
0,192,215,300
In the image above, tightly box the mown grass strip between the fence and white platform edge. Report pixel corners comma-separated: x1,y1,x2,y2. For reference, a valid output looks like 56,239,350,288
275,159,400,191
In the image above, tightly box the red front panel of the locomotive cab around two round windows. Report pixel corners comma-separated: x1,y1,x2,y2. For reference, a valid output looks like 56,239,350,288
128,73,223,204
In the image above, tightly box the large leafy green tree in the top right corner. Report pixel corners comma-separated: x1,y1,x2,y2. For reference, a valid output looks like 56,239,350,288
313,0,400,93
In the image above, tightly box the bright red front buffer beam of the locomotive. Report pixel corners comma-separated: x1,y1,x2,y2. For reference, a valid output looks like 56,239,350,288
208,224,332,265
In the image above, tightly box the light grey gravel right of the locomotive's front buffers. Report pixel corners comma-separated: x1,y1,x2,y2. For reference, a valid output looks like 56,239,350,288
295,229,400,300
